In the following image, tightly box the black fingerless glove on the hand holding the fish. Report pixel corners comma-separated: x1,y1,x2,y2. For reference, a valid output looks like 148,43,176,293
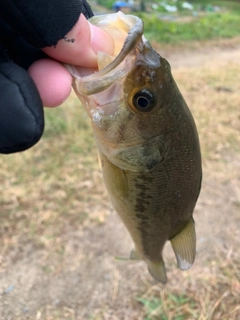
0,0,93,153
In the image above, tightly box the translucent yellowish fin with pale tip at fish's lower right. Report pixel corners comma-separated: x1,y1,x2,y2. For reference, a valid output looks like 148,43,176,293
170,219,196,270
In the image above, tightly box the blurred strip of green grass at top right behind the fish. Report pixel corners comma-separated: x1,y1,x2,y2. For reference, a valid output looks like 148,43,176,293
93,0,240,44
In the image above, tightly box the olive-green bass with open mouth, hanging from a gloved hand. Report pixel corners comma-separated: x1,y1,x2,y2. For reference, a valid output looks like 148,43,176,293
66,12,202,283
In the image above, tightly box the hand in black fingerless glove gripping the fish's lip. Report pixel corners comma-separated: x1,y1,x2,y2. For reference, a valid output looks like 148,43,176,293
0,0,112,154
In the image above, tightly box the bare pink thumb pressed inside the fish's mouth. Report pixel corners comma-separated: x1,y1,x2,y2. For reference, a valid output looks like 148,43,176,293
42,14,114,68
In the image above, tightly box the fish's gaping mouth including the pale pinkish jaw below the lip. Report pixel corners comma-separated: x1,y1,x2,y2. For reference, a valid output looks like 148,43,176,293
66,12,159,119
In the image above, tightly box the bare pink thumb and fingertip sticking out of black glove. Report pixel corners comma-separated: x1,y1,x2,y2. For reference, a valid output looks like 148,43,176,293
28,14,114,107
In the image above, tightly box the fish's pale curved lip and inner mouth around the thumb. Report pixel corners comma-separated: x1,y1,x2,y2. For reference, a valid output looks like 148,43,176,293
66,12,143,95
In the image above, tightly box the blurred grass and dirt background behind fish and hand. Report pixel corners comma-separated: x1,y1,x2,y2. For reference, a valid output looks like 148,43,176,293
0,0,240,320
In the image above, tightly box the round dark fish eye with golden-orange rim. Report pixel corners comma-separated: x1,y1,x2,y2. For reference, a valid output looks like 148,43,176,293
132,89,155,112
